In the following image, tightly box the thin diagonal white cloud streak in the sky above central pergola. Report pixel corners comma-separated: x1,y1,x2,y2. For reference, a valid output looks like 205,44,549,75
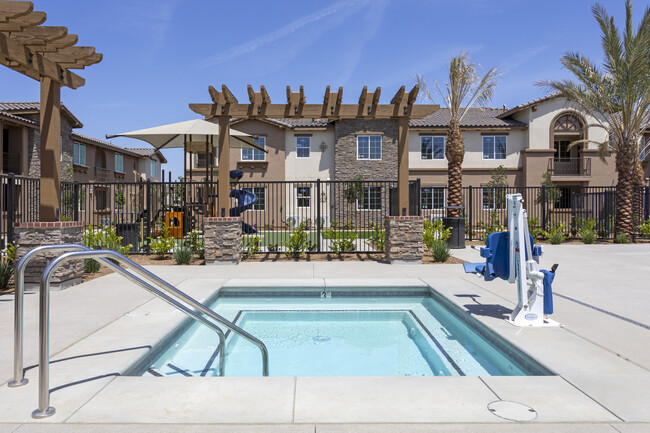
202,0,369,67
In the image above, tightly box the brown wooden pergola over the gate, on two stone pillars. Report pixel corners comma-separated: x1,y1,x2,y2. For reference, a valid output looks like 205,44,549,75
190,85,440,216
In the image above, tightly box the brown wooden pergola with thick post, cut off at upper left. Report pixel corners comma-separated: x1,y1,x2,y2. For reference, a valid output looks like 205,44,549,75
0,0,102,221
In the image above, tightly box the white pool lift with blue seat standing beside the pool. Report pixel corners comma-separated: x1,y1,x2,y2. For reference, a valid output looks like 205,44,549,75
463,194,560,326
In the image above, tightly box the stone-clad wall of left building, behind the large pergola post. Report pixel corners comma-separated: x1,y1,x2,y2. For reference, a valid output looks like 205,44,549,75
21,114,74,182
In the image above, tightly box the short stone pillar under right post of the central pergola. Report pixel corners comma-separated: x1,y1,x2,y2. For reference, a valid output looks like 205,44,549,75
384,216,424,264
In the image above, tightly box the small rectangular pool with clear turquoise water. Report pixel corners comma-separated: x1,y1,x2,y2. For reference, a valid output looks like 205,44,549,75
132,288,552,376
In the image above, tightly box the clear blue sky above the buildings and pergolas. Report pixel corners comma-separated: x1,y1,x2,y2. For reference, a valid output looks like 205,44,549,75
0,0,650,178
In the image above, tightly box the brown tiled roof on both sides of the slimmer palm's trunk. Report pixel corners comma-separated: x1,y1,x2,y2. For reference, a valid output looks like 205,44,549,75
409,107,528,128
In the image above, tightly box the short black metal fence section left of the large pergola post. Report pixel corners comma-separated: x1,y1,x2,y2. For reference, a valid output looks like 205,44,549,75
0,174,41,249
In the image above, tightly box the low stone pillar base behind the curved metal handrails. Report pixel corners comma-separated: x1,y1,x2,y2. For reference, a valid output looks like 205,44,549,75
14,221,84,291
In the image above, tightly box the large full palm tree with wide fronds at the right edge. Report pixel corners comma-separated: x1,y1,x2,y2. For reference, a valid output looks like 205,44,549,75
538,0,650,237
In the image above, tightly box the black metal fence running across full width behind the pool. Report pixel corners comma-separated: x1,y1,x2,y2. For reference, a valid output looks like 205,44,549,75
0,175,650,253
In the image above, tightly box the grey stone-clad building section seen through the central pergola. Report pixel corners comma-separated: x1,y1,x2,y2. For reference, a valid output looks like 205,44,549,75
331,119,397,227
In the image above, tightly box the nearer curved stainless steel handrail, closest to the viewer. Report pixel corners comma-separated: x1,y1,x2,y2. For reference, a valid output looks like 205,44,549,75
32,250,269,418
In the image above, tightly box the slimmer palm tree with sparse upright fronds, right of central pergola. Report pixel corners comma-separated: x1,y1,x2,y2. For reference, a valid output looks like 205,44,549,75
416,53,500,217
